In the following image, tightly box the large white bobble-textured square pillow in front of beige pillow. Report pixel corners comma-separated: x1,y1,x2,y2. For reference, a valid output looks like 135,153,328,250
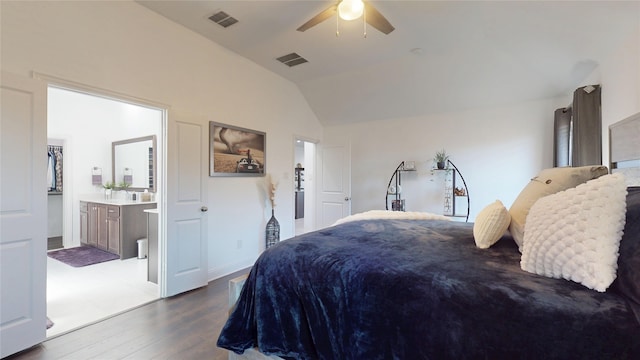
520,173,627,292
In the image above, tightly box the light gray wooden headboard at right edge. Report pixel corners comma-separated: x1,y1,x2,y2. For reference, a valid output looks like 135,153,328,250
609,113,640,186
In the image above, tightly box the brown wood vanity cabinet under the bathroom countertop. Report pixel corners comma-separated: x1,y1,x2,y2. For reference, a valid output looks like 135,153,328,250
80,201,156,259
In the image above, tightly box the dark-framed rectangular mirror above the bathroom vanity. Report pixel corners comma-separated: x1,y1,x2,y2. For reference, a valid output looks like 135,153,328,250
111,135,156,192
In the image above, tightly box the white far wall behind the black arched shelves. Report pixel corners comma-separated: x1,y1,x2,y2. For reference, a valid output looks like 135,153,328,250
325,98,569,221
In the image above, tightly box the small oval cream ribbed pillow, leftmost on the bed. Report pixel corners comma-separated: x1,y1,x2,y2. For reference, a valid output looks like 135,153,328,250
473,200,511,249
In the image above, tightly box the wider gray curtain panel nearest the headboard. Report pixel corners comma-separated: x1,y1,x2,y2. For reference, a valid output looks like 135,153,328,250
571,85,602,166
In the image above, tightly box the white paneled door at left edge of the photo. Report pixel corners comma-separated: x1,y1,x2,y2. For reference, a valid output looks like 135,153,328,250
0,72,47,357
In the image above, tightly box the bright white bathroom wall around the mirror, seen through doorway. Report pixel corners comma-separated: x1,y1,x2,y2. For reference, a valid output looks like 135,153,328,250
47,88,162,247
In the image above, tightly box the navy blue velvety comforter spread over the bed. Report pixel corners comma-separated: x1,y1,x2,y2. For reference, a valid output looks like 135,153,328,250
218,220,640,359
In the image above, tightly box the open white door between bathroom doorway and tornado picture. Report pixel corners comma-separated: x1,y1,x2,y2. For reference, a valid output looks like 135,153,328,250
160,113,209,297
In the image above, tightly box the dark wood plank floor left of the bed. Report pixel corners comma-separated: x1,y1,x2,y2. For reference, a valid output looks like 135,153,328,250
7,269,249,360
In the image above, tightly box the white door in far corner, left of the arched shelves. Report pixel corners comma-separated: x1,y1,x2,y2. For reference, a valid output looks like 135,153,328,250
317,144,351,228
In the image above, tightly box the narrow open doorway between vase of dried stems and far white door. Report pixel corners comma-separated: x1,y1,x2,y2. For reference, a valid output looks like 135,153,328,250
294,139,316,235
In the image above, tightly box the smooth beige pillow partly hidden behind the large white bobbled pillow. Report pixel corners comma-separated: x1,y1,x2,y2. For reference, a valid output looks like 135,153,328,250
509,165,609,252
